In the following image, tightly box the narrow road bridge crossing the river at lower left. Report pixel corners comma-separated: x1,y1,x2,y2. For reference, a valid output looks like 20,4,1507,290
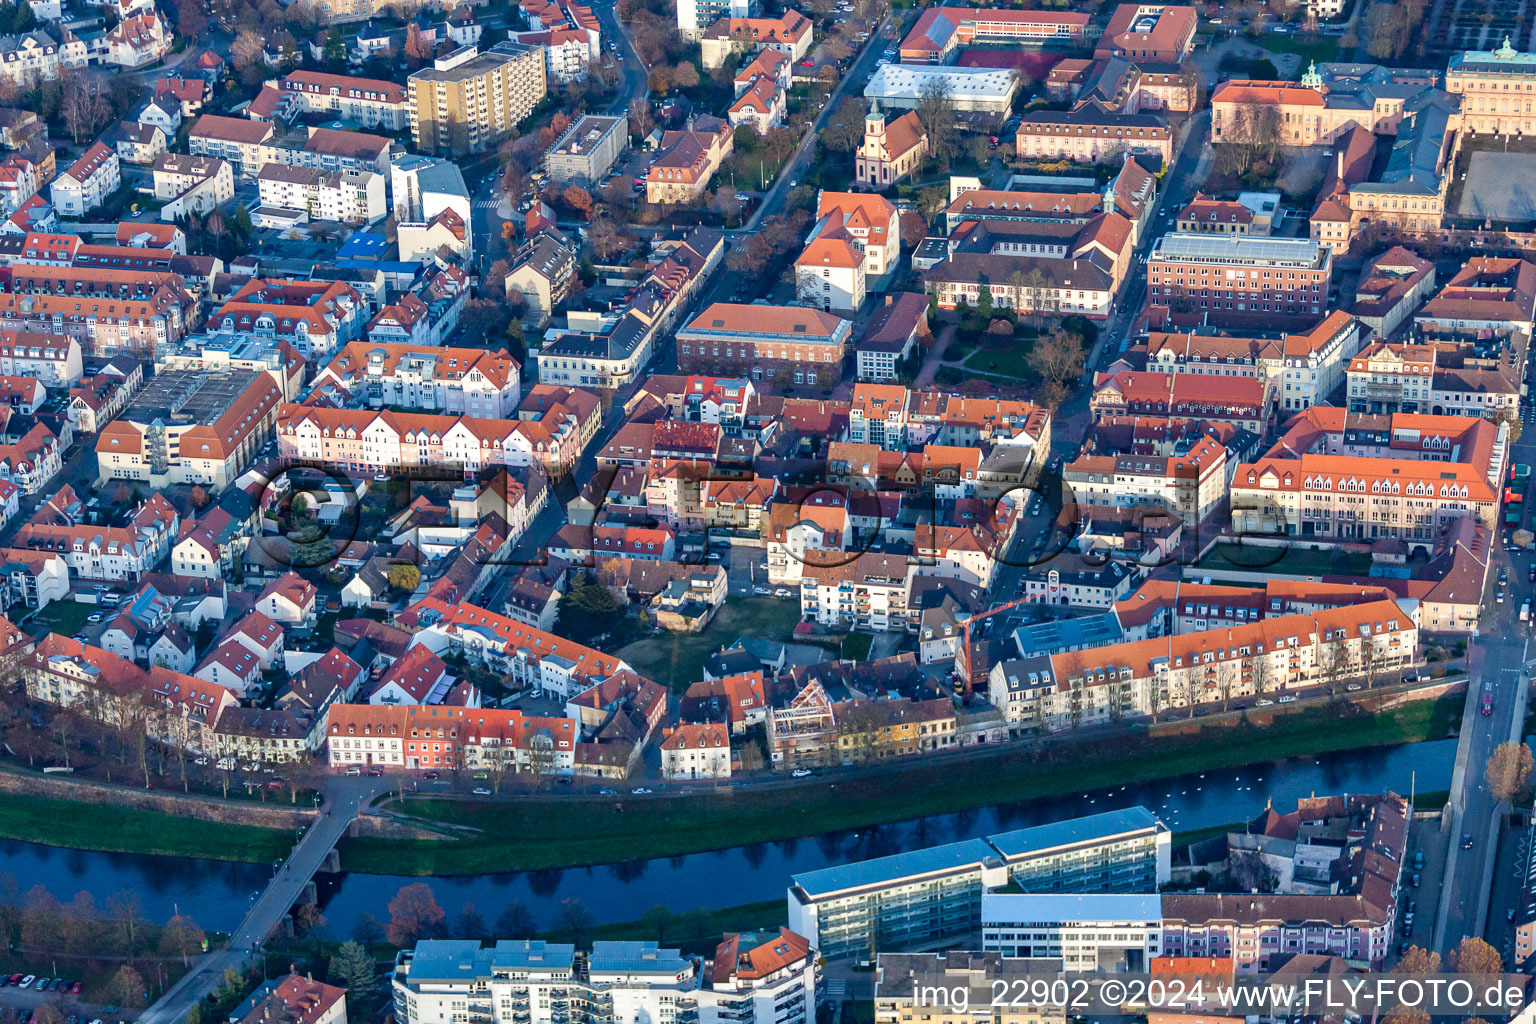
138,777,389,1024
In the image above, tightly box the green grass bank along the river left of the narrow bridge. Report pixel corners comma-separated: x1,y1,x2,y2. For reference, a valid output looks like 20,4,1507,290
0,792,293,863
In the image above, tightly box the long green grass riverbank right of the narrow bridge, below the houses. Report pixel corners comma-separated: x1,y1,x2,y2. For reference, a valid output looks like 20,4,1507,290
341,697,1461,875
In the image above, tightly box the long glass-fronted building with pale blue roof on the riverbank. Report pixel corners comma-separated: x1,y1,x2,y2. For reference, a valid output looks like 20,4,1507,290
788,808,1169,960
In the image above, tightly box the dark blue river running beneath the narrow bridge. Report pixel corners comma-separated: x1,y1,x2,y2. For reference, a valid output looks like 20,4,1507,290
0,740,1456,936
